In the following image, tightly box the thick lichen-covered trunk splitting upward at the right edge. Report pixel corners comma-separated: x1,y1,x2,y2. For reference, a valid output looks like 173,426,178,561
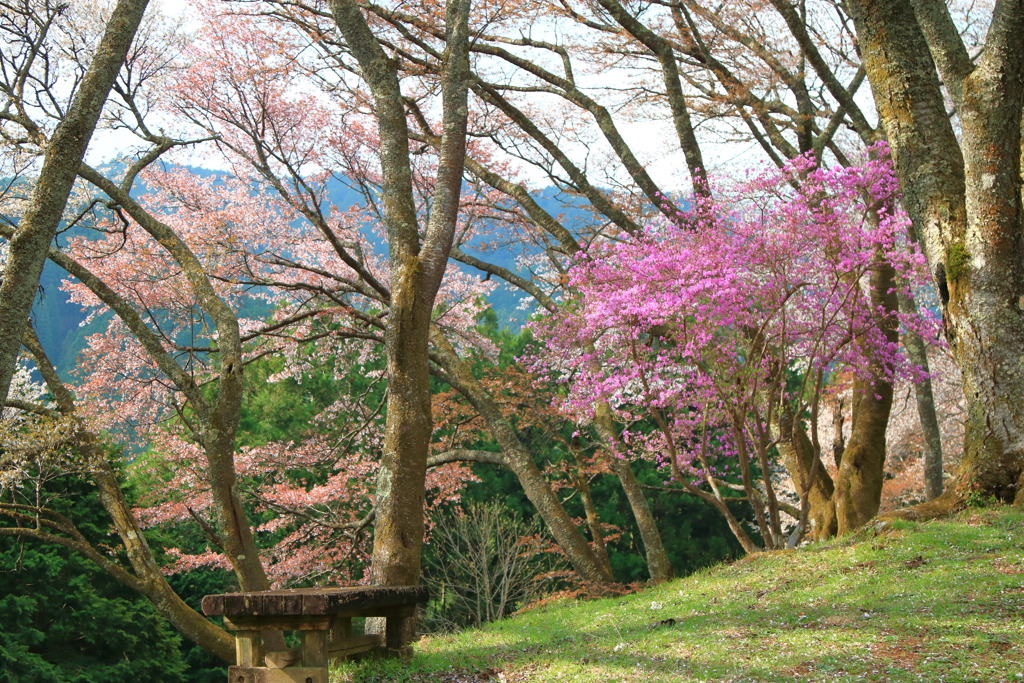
849,0,1024,507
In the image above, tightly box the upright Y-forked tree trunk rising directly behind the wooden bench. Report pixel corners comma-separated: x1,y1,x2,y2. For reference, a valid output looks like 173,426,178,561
331,0,470,585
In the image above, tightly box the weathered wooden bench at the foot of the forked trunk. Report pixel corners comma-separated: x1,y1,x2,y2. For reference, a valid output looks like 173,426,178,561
203,586,427,683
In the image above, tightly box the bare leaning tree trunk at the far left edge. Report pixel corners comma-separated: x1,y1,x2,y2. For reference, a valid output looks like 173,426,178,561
0,0,148,405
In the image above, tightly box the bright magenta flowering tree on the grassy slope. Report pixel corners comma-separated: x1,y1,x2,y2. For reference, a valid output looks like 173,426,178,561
534,147,936,552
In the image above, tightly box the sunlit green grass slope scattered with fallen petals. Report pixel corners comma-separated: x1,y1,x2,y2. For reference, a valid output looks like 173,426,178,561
332,508,1024,683
